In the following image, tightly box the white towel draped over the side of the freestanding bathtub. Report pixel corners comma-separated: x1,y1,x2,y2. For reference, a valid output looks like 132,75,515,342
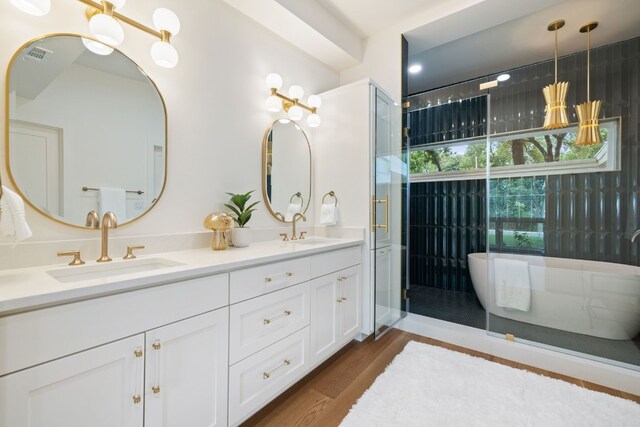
493,258,531,311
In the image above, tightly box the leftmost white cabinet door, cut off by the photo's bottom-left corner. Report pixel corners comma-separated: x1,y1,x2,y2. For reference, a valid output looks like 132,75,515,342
0,334,144,427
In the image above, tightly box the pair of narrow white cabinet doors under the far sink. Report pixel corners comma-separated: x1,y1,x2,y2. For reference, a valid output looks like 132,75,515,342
310,265,361,366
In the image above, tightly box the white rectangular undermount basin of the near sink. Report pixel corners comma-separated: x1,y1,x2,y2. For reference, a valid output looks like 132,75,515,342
47,258,184,283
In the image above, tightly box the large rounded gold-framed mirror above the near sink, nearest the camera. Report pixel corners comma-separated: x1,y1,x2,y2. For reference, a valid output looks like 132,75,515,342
6,35,167,227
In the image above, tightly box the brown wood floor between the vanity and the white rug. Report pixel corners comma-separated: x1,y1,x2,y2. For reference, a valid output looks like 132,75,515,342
243,329,640,427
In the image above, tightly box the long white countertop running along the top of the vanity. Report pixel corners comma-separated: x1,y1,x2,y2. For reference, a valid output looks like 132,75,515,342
0,239,363,316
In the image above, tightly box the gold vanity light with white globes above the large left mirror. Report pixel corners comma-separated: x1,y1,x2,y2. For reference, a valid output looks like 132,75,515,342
11,0,180,68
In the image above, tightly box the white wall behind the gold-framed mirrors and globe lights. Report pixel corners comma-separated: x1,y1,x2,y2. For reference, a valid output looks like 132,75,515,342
0,0,339,257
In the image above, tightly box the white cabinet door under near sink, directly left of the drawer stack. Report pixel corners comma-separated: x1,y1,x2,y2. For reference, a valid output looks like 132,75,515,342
144,308,229,427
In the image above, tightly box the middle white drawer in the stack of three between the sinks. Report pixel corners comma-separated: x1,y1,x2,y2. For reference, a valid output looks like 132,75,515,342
229,283,309,364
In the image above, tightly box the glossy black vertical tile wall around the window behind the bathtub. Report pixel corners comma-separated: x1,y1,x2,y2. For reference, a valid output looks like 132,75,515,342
408,38,640,292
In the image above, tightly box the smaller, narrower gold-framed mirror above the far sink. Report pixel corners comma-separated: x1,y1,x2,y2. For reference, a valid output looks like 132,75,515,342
262,119,311,222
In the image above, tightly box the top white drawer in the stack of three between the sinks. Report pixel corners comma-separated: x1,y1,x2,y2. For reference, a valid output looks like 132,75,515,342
229,258,310,304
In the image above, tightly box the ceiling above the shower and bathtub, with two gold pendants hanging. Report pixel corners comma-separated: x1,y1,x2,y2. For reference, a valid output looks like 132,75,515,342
405,0,640,93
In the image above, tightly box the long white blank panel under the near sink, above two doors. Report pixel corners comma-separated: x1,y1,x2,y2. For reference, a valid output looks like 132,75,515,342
0,274,229,375
